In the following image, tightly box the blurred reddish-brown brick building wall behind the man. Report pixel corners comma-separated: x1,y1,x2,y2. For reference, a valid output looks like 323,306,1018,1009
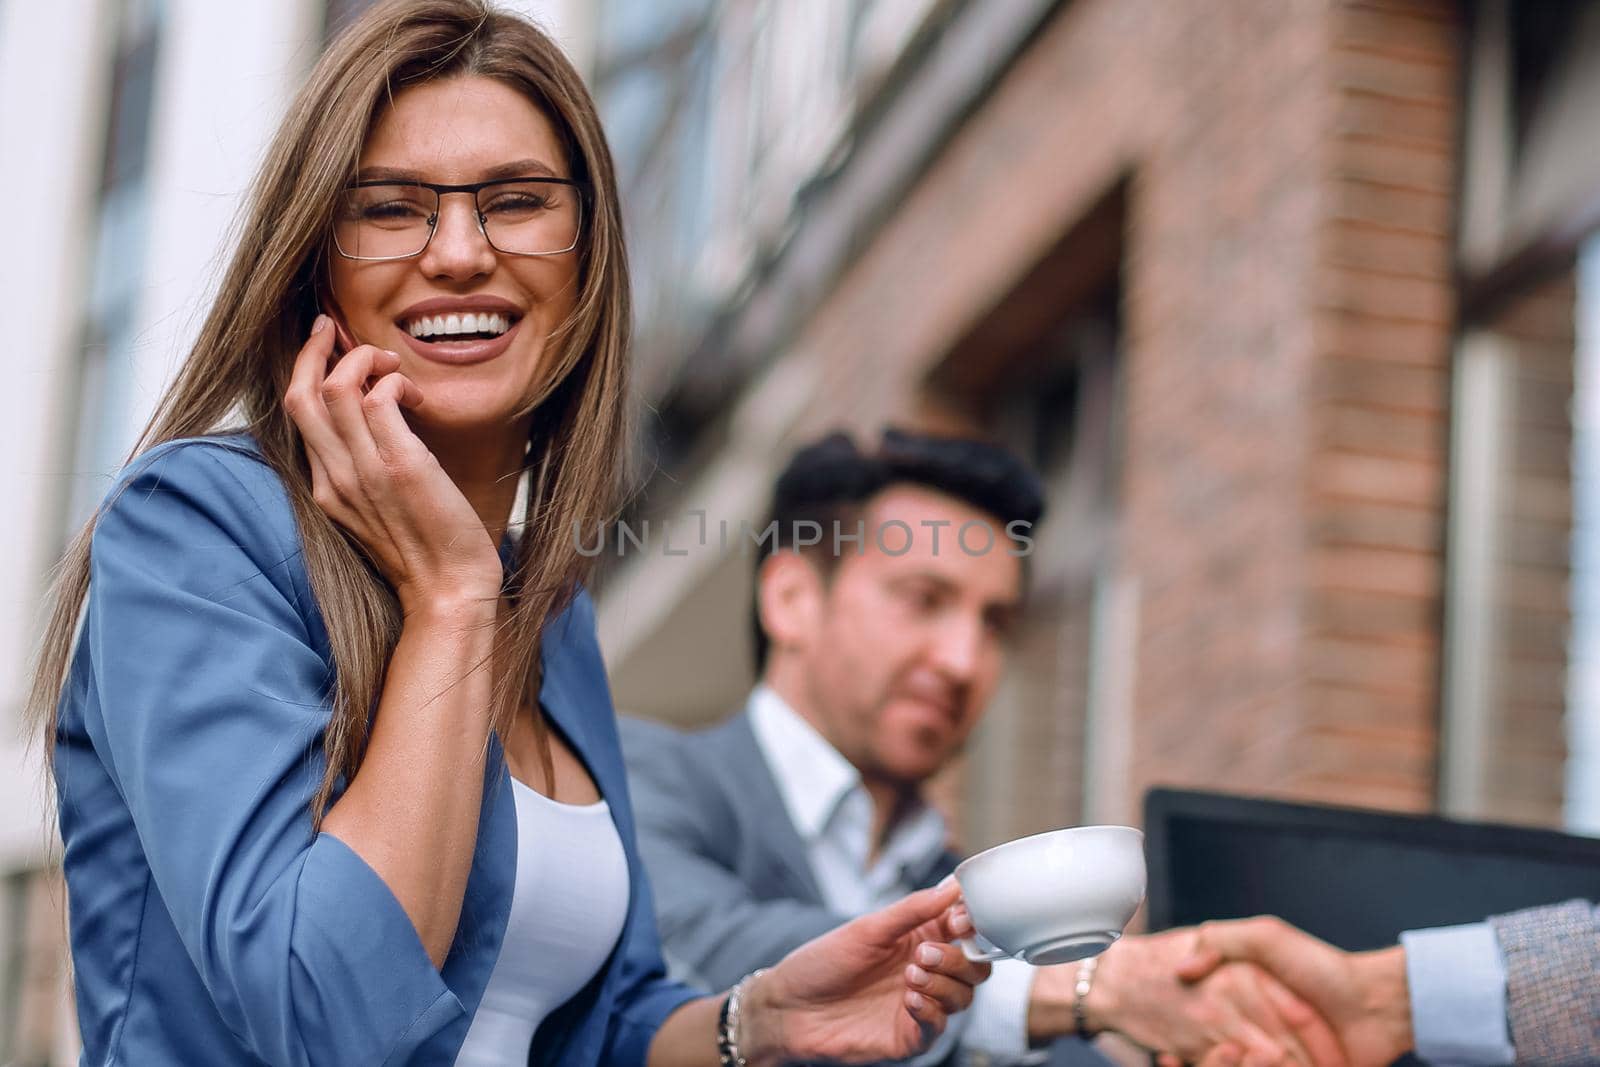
768,0,1504,817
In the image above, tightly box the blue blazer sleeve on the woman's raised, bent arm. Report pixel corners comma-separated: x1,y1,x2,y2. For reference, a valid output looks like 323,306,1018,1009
82,443,464,1067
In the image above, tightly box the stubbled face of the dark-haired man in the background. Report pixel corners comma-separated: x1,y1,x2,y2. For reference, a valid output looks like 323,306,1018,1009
797,486,1022,785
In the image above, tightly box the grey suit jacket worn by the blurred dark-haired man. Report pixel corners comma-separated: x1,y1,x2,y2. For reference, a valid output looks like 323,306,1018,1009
619,712,1109,1067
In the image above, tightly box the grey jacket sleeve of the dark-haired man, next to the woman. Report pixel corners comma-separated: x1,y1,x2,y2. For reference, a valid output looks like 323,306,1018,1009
622,721,850,990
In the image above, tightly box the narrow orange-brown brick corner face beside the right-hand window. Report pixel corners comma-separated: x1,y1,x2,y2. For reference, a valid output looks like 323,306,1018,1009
1294,3,1459,809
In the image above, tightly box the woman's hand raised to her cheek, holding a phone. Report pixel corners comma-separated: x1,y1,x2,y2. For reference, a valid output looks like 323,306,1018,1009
283,315,501,614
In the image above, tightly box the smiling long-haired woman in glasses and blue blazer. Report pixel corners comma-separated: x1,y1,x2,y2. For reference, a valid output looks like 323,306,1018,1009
30,0,986,1067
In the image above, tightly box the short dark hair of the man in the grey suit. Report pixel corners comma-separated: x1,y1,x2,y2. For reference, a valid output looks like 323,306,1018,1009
750,427,1045,673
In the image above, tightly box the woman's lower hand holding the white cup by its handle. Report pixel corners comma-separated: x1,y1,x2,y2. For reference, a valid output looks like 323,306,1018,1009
746,878,989,1064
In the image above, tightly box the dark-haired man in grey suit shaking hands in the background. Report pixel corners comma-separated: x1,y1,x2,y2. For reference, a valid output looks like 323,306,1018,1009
622,430,1339,1064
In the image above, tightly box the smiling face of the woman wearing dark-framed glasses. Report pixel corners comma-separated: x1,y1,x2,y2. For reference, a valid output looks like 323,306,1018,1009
328,75,581,440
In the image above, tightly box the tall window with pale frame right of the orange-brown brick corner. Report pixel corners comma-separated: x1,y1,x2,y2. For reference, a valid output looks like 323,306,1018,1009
1440,0,1600,830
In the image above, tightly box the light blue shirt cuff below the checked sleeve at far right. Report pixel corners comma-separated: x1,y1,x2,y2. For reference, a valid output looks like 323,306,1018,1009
1400,923,1515,1067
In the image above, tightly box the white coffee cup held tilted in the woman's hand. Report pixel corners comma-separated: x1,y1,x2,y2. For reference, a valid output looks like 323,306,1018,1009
955,825,1144,966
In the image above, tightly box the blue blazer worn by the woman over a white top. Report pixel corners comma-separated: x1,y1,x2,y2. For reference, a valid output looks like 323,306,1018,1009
54,435,694,1067
